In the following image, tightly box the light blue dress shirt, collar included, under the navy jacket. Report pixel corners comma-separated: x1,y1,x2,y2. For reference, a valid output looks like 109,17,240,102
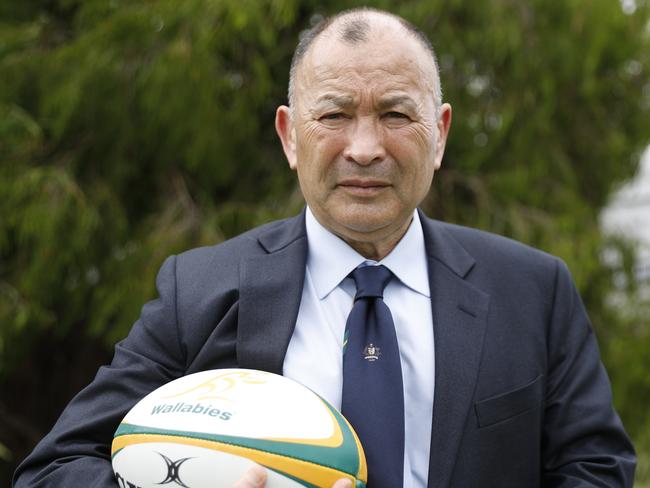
283,208,435,488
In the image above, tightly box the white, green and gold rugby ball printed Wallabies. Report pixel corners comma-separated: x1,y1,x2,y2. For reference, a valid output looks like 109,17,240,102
112,369,367,488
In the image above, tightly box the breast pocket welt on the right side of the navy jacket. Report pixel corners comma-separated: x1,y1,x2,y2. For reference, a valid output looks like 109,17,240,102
474,375,544,427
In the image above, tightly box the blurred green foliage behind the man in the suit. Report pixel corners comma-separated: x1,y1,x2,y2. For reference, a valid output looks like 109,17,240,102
0,0,650,483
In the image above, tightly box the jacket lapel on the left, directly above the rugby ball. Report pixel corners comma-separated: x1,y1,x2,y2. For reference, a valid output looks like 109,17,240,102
237,212,307,374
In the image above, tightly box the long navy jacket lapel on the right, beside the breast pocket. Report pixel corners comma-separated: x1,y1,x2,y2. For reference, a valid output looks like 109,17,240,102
422,217,489,488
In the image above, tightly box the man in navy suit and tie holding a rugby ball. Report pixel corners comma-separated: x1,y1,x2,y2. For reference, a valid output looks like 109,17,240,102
15,5,635,488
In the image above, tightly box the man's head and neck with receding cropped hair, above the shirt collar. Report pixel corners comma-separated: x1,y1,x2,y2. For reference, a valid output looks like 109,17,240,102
276,9,451,258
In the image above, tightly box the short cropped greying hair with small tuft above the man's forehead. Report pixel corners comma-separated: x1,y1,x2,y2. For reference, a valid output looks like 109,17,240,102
288,7,442,117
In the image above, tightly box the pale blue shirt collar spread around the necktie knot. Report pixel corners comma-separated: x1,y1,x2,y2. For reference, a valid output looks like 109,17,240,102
305,207,431,300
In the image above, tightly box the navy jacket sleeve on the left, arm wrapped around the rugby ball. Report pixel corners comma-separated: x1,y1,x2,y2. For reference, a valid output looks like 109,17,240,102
14,256,186,488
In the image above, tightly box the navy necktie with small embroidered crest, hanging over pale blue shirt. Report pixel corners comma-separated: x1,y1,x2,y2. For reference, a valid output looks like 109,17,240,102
341,266,404,488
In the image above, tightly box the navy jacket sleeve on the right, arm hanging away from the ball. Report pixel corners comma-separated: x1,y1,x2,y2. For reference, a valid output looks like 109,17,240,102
542,261,636,487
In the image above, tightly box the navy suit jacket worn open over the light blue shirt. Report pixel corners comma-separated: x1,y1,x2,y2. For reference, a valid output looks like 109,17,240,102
15,215,635,488
